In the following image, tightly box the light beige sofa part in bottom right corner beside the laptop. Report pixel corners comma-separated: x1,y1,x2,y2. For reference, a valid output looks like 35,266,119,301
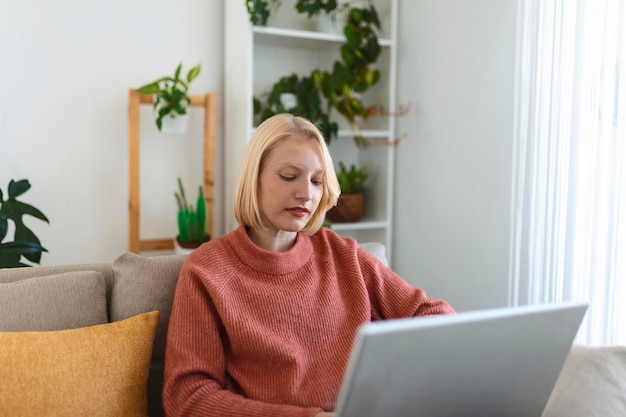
542,346,626,417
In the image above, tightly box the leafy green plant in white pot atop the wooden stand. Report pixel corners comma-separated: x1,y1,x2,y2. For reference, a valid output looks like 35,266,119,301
137,63,200,133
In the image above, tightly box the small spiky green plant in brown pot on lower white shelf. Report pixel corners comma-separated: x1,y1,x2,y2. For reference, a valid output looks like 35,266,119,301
326,162,369,223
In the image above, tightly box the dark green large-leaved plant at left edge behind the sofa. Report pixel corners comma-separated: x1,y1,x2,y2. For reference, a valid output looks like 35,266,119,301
0,179,50,268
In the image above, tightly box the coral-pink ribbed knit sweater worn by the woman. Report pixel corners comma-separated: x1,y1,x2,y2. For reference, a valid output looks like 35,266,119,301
163,227,453,417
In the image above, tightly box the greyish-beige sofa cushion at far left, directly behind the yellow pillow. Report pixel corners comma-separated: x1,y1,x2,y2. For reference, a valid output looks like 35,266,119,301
0,271,108,332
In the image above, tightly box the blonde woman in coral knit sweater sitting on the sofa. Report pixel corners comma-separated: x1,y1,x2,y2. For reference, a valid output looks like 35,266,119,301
163,114,454,417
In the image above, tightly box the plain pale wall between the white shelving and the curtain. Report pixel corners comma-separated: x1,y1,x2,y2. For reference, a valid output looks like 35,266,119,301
393,0,517,310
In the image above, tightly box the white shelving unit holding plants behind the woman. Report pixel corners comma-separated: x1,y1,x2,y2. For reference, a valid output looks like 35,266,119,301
224,0,399,264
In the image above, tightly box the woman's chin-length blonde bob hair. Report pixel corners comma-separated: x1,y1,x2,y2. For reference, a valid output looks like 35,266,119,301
233,113,341,236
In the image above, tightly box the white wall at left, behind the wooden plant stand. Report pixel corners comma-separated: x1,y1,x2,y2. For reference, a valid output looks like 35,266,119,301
0,0,223,265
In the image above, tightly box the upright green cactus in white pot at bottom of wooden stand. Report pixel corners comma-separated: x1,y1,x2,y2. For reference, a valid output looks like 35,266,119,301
174,177,211,253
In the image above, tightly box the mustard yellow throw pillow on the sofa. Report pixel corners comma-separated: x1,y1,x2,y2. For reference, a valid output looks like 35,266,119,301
0,311,159,417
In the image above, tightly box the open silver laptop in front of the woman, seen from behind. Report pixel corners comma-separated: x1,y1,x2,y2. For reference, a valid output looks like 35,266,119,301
335,302,587,417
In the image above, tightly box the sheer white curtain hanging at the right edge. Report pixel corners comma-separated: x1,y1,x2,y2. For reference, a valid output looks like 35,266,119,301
509,0,626,345
